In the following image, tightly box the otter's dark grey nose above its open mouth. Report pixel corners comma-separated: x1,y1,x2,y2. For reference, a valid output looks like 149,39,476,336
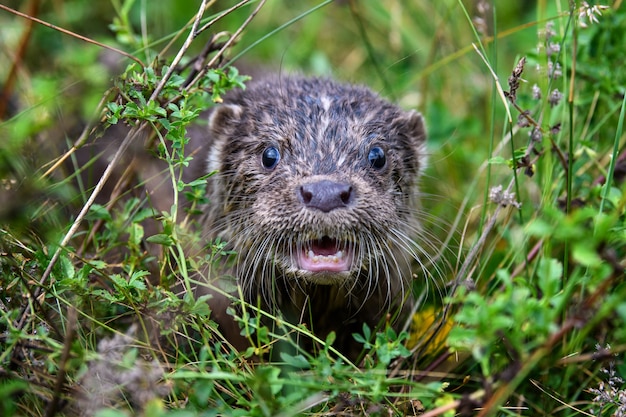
297,180,354,213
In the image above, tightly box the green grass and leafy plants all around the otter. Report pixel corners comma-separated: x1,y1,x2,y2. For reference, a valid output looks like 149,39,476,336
0,0,626,416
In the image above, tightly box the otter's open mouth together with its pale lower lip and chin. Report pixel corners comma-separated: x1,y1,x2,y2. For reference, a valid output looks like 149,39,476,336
294,236,354,281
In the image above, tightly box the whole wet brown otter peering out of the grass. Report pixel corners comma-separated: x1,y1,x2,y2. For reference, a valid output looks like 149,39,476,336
197,76,426,358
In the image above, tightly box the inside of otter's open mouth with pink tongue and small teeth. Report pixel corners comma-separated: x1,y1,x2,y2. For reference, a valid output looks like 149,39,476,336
298,236,351,272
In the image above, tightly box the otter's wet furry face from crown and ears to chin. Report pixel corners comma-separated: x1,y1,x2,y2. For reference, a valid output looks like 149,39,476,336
208,78,425,300
